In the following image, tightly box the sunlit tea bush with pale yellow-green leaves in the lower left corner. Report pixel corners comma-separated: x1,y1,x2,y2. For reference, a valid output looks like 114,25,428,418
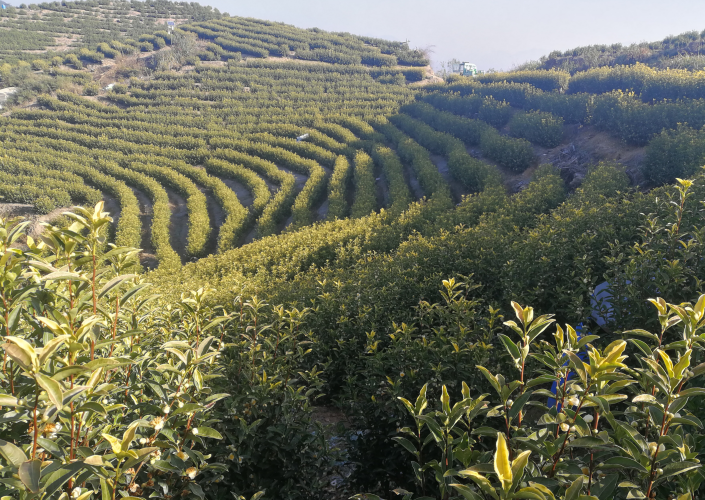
0,202,232,499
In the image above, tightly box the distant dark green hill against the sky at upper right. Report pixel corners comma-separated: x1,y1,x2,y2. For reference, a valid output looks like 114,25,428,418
516,30,705,73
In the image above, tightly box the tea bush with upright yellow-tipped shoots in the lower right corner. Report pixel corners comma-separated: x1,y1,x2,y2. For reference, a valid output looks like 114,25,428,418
355,295,705,500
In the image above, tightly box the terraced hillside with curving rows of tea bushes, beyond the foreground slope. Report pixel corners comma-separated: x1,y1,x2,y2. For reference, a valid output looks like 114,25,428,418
0,12,705,286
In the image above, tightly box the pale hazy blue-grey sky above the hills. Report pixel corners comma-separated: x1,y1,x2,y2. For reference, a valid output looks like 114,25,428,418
199,0,705,69
